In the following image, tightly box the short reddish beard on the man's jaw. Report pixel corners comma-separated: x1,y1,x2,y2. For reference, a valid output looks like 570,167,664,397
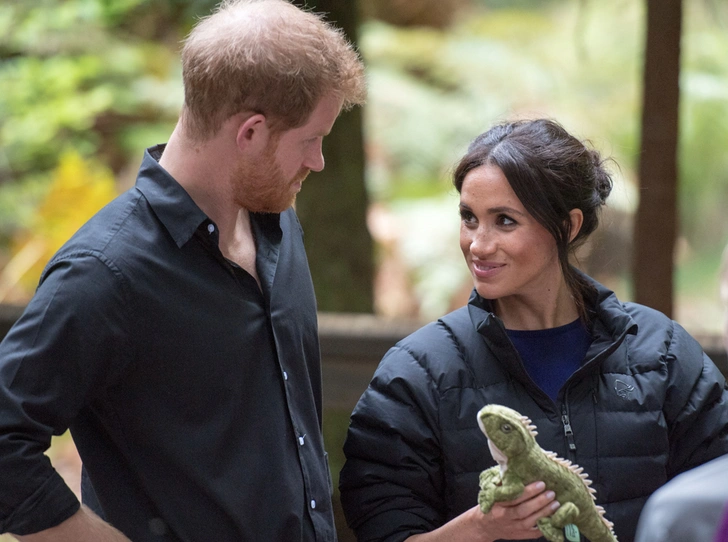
230,141,309,213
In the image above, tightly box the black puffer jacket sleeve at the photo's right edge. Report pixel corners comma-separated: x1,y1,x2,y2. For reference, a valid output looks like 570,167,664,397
665,323,728,478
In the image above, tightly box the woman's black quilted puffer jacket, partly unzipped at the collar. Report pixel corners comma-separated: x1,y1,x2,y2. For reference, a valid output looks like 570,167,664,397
340,283,728,542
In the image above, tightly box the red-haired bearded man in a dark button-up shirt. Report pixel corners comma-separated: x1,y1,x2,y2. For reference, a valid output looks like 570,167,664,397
0,0,364,542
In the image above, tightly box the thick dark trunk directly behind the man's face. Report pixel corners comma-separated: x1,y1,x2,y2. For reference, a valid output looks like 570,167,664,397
296,0,374,312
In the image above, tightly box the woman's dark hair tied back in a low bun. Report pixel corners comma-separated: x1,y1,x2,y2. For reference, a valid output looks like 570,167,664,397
453,119,612,322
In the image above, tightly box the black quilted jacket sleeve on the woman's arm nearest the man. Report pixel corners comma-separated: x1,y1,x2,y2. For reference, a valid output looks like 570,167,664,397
339,343,444,542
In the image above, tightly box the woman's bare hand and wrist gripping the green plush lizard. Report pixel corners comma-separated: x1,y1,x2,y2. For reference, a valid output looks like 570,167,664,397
407,482,560,542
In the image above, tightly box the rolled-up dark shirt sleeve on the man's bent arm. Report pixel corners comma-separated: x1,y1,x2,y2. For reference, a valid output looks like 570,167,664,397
0,255,129,535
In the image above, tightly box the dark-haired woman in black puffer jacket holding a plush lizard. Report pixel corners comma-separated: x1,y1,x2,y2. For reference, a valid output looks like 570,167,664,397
340,120,728,542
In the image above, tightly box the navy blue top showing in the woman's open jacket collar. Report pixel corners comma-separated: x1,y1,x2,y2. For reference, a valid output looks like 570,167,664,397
506,319,592,401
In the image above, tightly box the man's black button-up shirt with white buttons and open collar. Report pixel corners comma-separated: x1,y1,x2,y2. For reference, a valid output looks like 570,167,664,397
0,146,336,542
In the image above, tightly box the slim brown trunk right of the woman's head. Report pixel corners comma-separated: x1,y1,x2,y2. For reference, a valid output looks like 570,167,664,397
632,0,682,316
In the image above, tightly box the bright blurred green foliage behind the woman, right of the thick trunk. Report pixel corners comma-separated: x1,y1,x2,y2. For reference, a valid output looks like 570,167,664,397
361,0,728,331
